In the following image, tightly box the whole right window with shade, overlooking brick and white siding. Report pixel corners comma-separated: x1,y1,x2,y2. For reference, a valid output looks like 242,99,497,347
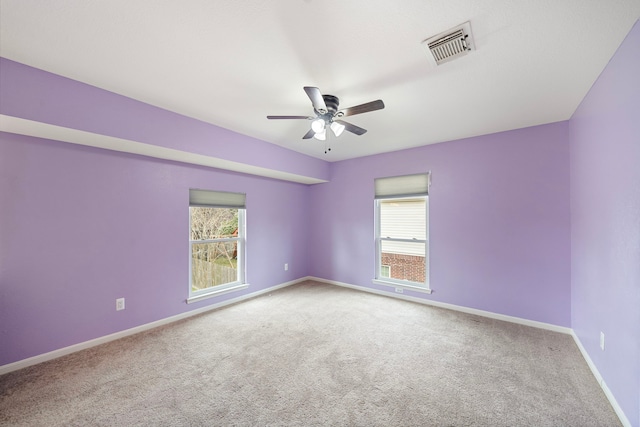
374,174,430,292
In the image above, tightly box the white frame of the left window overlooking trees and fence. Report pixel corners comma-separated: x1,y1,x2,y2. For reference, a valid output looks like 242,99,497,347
187,190,249,304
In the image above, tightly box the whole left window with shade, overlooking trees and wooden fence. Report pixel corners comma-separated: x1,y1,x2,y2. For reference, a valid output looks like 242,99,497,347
188,190,247,302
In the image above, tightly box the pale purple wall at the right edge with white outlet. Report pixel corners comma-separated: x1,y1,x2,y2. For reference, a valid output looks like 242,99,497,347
569,22,640,427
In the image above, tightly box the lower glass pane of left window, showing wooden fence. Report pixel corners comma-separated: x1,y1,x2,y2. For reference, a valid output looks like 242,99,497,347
191,241,238,292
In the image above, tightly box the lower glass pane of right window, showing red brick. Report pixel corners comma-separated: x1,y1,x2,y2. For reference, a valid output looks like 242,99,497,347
380,240,426,283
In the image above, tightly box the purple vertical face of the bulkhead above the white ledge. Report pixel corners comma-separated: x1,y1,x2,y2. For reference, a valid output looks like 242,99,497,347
0,58,329,179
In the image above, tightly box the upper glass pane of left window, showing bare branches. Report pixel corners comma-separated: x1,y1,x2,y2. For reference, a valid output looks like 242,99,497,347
189,206,238,240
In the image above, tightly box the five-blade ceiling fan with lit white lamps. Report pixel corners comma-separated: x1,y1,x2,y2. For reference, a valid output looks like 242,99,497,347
267,86,384,141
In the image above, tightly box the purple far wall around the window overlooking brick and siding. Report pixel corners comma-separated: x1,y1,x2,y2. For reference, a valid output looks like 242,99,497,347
310,122,570,326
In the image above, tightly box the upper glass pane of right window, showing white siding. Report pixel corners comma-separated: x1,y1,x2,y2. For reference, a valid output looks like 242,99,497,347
380,199,427,240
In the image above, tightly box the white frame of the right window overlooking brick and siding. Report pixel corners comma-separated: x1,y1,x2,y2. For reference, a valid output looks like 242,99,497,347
372,173,432,294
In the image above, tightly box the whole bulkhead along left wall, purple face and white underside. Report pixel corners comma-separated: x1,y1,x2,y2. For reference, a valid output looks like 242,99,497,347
0,58,330,184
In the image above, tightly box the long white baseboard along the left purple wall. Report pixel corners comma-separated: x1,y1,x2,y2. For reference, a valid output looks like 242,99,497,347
0,277,309,375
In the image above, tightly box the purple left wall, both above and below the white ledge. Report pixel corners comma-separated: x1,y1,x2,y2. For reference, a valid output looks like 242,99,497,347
0,58,329,365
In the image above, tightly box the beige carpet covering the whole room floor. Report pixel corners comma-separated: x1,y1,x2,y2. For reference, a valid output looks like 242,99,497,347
0,282,620,427
